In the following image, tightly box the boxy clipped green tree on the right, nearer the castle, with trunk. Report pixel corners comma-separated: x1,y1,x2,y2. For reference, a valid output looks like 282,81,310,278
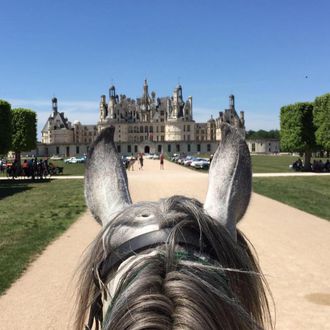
280,102,316,170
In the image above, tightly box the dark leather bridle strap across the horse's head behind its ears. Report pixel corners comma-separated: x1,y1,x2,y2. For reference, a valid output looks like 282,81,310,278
86,228,213,329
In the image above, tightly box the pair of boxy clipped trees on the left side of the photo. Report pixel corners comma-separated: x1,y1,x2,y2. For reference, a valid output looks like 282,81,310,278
0,100,37,160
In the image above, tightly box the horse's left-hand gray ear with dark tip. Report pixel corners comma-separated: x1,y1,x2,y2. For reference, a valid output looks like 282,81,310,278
85,127,132,226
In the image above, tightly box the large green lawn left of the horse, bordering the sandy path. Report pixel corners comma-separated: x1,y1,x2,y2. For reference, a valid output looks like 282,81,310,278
0,180,86,293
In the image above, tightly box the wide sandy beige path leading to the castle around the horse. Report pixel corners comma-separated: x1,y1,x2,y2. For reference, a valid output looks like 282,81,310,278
0,160,330,330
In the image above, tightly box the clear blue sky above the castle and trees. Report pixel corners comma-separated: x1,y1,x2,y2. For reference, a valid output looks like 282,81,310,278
0,0,330,136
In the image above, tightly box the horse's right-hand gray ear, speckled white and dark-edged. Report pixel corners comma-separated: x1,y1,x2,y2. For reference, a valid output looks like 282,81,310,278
204,124,252,240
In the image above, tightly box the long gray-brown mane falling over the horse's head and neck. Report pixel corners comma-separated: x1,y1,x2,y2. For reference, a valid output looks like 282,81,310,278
76,196,271,330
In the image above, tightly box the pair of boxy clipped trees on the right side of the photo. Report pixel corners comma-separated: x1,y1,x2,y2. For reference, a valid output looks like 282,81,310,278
280,93,330,169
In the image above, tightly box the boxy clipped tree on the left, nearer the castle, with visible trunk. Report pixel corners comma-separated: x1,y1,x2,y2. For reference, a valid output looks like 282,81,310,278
11,108,37,160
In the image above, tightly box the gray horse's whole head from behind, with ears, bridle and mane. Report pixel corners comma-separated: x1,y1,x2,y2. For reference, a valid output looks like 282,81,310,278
77,124,268,329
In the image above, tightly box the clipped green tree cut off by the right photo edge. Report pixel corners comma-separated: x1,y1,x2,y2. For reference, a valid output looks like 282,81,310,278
314,94,330,151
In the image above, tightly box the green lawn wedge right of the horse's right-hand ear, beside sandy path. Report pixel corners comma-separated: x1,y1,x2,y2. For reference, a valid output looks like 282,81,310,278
253,176,330,220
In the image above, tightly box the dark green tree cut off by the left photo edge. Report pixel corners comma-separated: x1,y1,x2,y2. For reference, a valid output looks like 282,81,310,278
0,100,11,155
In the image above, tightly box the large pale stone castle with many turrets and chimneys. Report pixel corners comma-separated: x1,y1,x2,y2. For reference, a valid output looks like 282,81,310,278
39,80,245,157
